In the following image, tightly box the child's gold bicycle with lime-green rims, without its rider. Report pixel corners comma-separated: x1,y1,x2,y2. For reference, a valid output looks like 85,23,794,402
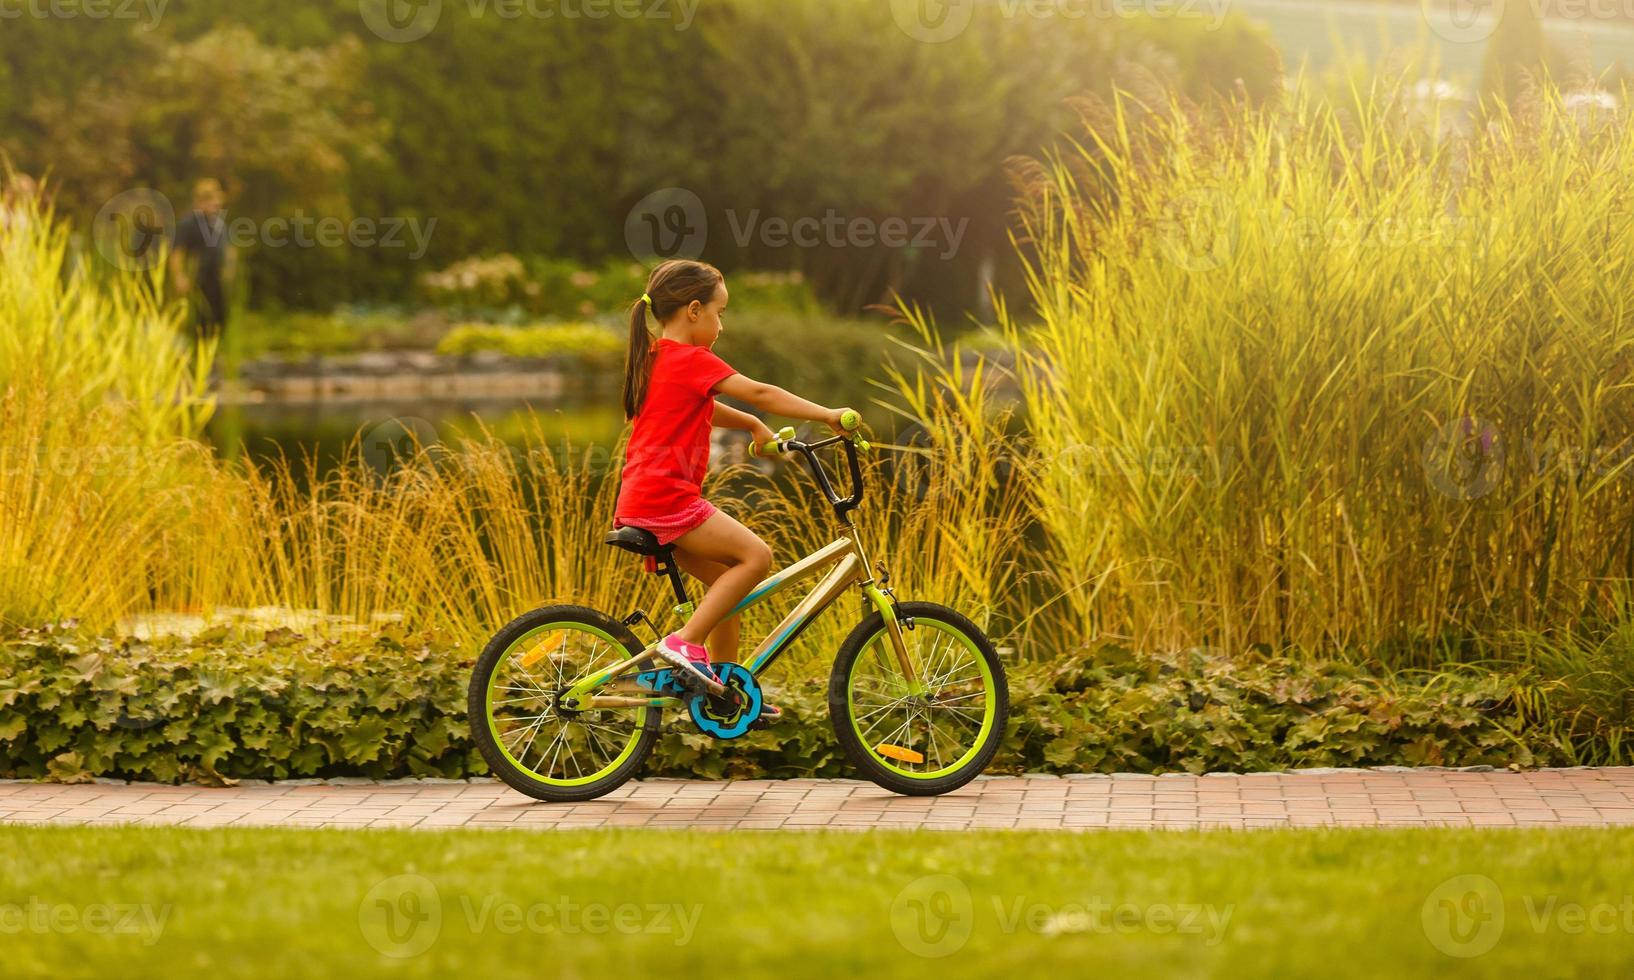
469,412,1010,802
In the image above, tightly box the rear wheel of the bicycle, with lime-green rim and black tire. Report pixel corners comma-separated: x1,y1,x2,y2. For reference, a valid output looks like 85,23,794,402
467,606,660,804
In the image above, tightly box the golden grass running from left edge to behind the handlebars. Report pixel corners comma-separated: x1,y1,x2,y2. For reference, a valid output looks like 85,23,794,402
0,194,1028,653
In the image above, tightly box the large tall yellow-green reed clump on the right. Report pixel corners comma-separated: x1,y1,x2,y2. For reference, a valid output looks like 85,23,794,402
1010,90,1634,666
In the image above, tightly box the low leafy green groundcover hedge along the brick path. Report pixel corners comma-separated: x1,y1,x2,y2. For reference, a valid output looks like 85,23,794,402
0,627,1614,782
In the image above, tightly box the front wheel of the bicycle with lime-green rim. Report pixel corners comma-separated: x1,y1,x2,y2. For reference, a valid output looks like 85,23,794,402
828,603,1010,795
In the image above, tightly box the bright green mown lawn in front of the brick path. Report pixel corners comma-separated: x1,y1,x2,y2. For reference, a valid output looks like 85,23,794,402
0,828,1634,978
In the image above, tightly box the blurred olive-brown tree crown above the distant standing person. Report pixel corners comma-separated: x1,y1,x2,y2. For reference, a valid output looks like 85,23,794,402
13,26,381,231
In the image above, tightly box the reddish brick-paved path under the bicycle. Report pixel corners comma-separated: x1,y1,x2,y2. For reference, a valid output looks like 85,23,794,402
0,768,1634,830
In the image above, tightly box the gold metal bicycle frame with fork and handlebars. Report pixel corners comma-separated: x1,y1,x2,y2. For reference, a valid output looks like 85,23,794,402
562,436,925,709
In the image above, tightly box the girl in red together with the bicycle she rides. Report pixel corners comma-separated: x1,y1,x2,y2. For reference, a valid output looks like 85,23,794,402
466,261,1008,802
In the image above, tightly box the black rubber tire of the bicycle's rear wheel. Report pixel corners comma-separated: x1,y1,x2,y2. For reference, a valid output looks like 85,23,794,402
466,606,662,804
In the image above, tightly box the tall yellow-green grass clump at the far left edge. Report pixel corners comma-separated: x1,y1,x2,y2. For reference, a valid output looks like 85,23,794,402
0,195,217,622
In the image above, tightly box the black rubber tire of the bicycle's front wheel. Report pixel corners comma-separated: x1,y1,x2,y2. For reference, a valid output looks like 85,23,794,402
828,603,1010,795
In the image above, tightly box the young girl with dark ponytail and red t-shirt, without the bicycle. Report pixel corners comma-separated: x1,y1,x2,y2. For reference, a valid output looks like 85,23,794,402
614,260,845,708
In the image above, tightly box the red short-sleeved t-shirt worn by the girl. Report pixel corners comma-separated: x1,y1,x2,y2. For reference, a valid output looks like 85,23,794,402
613,338,737,519
